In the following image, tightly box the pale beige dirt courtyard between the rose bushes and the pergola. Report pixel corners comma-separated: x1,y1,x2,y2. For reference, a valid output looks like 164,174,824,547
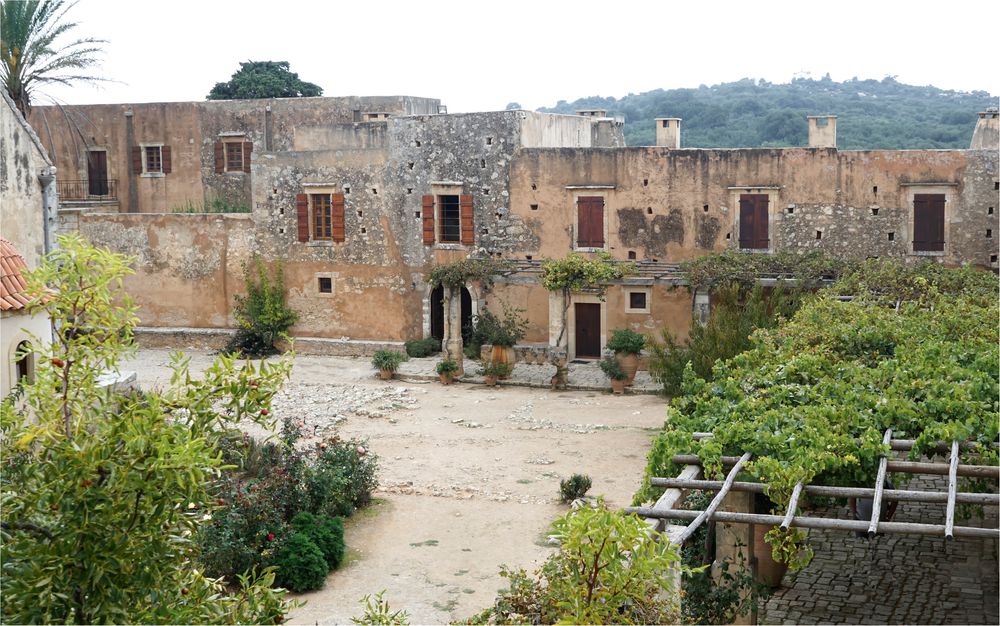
124,349,665,624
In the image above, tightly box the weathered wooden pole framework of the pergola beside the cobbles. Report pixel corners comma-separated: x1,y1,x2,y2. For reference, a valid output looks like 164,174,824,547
625,429,1000,545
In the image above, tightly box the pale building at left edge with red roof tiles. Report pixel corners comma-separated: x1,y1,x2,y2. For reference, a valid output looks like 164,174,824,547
0,89,56,397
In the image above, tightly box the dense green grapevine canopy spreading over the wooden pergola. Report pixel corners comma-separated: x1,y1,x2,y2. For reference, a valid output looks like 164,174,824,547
635,262,1000,566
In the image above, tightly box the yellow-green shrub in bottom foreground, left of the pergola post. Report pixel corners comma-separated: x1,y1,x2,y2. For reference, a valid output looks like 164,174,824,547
470,501,680,624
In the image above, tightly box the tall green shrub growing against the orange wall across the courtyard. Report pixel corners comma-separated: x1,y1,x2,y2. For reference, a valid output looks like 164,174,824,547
223,256,298,357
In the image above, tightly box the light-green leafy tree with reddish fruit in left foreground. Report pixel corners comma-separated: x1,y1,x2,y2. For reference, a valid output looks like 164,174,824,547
0,236,290,624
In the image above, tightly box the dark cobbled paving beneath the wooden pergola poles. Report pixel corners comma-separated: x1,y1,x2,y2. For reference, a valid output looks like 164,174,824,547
758,477,1000,624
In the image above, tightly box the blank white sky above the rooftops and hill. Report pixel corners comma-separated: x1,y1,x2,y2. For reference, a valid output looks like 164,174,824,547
36,0,1000,113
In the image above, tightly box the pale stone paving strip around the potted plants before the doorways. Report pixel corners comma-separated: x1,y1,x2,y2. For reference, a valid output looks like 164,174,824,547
396,357,662,393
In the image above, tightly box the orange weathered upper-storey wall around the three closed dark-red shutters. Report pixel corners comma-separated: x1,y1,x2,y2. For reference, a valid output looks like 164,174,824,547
511,148,997,266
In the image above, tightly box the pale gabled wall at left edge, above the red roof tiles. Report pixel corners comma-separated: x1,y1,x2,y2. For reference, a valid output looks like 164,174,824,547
0,93,52,269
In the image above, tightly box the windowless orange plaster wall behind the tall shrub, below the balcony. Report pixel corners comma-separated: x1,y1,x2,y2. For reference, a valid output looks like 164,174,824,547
79,214,257,328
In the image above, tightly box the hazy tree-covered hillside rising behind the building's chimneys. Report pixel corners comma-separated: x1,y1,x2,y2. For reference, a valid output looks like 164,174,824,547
539,75,997,150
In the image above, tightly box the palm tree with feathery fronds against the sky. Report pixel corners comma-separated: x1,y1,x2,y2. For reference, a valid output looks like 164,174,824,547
0,0,106,116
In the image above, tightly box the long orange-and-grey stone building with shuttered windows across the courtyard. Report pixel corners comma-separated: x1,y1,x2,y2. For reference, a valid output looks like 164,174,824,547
23,97,998,358
